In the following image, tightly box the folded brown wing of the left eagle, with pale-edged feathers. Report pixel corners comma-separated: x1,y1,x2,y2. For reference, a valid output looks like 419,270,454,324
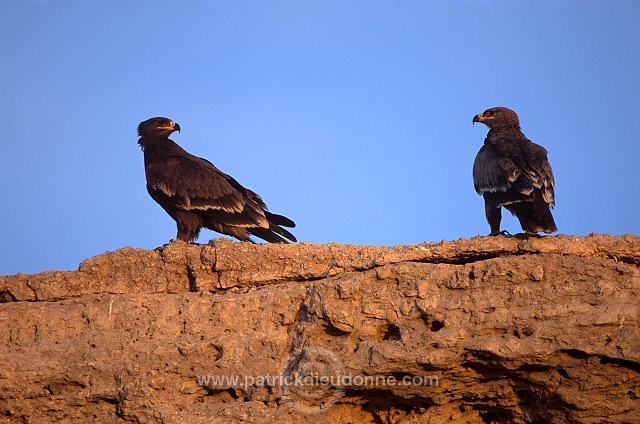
146,152,269,228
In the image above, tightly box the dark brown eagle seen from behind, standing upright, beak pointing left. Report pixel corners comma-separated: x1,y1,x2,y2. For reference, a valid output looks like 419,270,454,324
472,107,558,236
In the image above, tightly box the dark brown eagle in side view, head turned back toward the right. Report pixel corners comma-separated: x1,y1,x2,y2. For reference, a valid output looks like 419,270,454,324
138,117,296,243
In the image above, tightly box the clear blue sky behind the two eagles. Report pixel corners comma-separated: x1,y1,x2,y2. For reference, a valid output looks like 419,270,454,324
0,0,640,274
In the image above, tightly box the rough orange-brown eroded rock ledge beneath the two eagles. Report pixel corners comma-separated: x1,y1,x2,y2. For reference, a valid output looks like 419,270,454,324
0,235,640,424
